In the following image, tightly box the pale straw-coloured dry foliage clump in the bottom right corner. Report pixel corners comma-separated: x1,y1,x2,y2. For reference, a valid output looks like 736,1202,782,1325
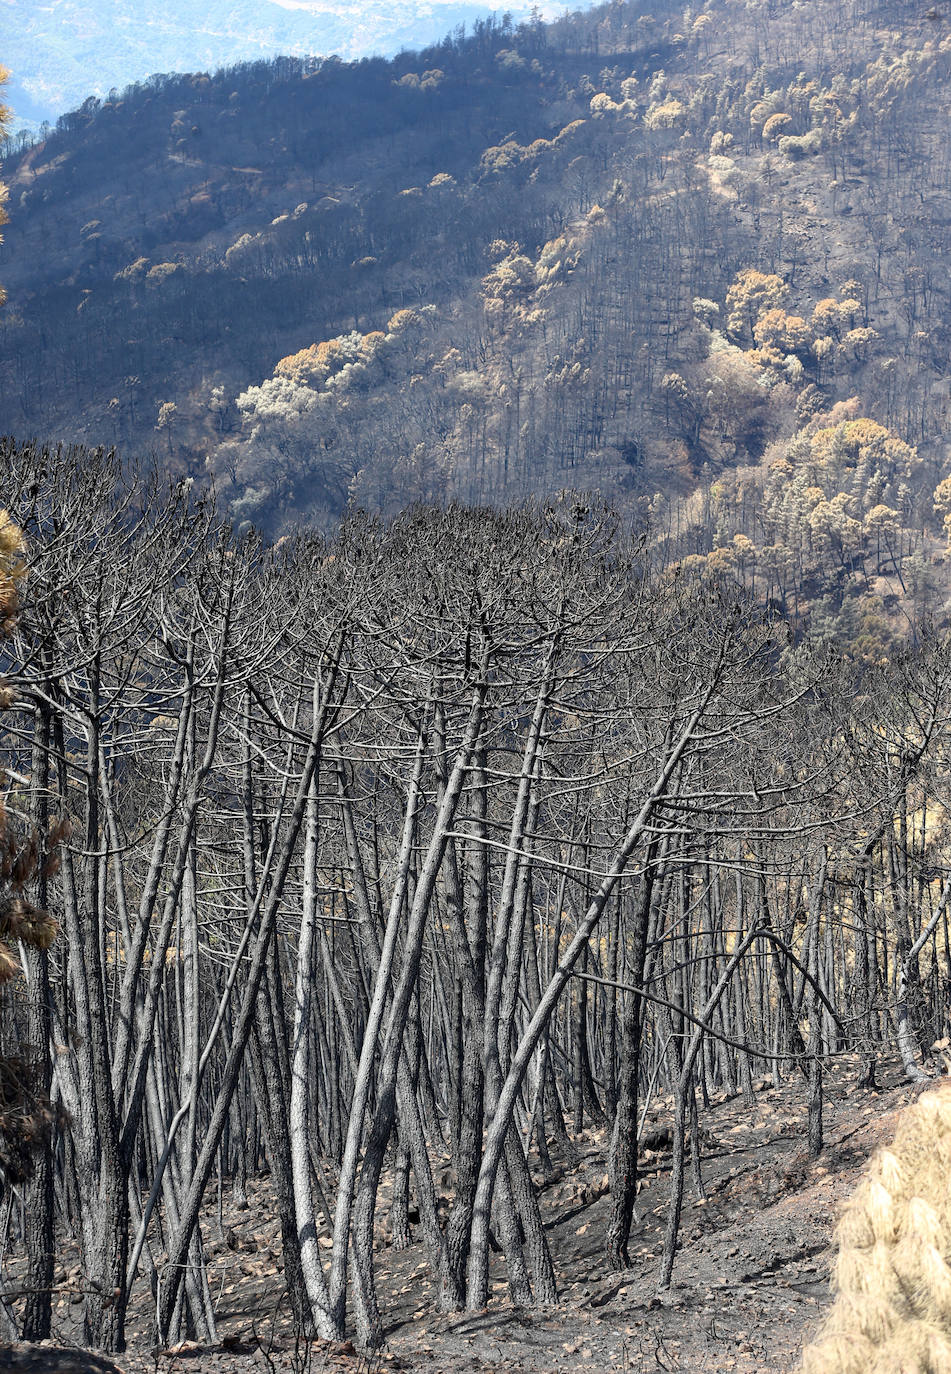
803,1083,951,1374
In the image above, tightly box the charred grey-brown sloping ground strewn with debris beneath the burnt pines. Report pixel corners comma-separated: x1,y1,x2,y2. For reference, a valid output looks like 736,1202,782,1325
0,1059,915,1374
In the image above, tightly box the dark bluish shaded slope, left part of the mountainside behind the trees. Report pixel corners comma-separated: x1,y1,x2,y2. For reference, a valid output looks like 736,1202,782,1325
0,4,658,483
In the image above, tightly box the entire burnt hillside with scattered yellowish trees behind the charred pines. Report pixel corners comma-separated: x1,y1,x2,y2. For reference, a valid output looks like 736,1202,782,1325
0,0,951,657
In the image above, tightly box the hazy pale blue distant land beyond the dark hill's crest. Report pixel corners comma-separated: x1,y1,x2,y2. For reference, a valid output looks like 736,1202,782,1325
0,0,563,131
